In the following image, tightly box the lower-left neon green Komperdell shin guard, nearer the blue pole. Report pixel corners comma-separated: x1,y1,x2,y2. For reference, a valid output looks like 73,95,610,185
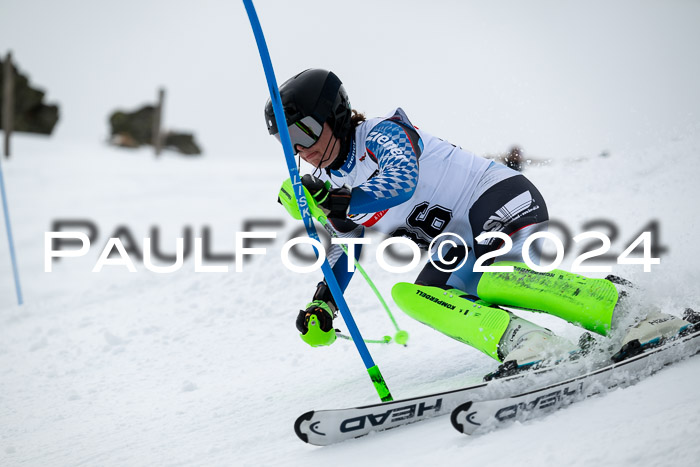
391,282,510,362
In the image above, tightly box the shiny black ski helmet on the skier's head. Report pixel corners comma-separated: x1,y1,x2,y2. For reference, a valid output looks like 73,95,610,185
265,68,352,148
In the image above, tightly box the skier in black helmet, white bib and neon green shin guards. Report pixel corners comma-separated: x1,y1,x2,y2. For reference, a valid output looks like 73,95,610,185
265,69,690,369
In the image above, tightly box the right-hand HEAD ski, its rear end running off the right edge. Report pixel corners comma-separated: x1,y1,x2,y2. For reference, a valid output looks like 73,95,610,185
450,331,700,434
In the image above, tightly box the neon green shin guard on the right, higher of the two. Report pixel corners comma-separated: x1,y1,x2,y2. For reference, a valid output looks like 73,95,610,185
477,261,618,335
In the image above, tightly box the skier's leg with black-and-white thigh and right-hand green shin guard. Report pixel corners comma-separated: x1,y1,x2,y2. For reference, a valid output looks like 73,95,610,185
461,177,618,334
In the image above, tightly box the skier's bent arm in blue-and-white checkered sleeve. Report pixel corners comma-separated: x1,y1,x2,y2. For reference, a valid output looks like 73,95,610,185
348,120,423,214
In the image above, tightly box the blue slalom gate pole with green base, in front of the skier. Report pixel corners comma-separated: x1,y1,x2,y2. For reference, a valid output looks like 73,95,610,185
243,0,393,401
